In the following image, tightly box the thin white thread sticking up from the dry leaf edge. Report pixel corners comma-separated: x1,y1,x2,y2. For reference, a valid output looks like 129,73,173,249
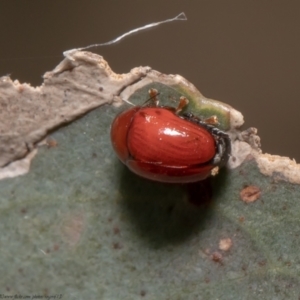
64,12,187,57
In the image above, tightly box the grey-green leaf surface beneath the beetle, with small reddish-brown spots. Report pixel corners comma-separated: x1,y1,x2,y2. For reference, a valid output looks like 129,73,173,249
0,96,300,300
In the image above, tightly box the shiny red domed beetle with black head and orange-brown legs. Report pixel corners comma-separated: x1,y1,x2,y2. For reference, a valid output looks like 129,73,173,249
111,89,230,183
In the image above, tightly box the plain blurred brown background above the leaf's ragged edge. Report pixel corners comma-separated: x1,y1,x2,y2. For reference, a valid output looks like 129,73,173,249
0,0,300,162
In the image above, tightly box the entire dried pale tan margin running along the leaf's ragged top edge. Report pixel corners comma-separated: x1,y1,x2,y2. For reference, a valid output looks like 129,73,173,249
0,50,300,184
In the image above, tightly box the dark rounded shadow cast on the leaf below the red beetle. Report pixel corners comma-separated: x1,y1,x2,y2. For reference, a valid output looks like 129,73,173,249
119,165,229,248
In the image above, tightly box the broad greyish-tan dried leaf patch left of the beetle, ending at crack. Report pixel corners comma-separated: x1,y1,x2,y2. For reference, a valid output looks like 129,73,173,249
0,51,150,177
